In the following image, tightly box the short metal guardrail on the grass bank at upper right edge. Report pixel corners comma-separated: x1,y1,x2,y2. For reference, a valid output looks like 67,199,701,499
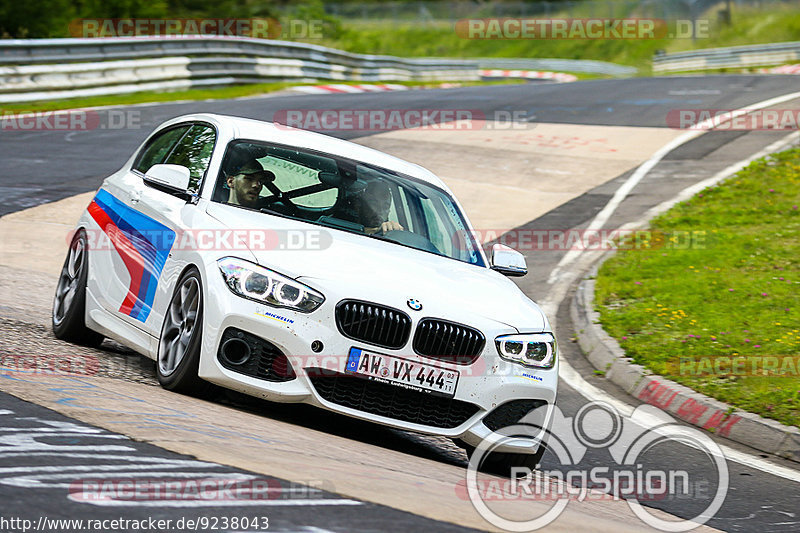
653,41,800,72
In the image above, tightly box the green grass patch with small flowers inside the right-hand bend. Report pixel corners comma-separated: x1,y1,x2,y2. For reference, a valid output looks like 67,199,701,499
596,144,800,426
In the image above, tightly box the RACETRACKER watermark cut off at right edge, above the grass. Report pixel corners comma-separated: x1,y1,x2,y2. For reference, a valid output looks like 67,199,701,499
666,109,800,131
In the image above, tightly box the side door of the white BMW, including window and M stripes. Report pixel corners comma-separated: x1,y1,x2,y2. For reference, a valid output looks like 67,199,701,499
91,123,216,335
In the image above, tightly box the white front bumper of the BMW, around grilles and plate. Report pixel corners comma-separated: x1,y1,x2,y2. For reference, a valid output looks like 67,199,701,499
199,265,558,453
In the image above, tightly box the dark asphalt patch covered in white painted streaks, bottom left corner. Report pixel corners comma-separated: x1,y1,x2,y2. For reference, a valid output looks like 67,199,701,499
0,393,482,531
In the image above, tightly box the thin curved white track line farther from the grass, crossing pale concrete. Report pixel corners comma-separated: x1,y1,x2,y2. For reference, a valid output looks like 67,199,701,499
547,92,800,285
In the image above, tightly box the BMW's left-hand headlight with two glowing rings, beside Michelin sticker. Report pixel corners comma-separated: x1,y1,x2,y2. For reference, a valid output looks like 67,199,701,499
217,257,325,313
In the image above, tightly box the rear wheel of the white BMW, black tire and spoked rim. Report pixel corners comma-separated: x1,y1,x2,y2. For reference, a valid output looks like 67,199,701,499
52,229,103,347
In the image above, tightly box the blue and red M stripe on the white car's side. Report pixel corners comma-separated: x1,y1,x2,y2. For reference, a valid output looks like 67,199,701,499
88,189,175,322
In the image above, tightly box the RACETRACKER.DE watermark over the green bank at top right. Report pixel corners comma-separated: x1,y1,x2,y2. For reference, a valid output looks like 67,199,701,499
455,17,710,40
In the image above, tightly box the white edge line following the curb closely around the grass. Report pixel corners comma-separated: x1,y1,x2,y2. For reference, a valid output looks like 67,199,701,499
541,128,800,483
